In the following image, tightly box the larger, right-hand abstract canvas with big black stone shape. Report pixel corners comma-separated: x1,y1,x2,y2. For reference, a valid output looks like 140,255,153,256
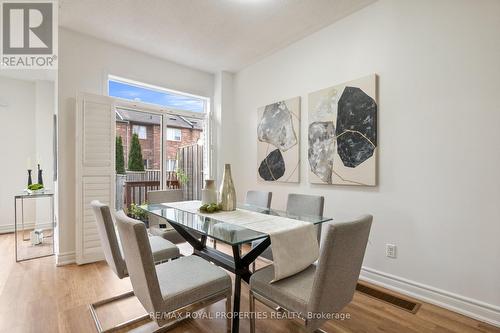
307,74,378,186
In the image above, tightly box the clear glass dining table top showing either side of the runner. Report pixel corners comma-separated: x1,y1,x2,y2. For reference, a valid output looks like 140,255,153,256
140,203,332,245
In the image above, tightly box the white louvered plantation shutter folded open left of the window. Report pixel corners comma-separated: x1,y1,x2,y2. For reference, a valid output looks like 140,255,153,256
76,94,115,265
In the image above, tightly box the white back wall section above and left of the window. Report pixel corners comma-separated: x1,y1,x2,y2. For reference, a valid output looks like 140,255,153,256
58,29,214,264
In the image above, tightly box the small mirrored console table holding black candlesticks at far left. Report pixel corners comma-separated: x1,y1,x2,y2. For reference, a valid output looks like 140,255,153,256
14,190,55,262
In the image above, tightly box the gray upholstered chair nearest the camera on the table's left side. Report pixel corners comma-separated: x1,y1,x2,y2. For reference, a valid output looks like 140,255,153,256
115,212,232,332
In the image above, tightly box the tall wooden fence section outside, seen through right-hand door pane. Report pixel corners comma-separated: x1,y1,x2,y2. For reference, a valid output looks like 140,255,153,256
177,144,203,200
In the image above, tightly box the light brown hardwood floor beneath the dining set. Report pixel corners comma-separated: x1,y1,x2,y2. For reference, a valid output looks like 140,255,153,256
0,234,500,333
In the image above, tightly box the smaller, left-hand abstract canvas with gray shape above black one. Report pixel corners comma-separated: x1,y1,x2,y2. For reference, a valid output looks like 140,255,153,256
257,97,300,183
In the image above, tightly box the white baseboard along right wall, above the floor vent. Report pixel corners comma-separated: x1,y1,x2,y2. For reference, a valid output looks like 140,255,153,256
359,267,500,327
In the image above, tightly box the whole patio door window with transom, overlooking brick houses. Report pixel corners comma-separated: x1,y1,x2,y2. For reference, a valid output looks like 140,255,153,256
109,75,213,200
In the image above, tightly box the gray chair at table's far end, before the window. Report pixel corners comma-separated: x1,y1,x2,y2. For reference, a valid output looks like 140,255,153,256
148,190,186,244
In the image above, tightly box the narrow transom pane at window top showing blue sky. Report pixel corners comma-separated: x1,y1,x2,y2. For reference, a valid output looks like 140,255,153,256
108,76,206,113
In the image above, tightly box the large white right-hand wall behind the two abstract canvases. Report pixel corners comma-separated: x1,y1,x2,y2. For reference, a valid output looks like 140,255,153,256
228,0,500,325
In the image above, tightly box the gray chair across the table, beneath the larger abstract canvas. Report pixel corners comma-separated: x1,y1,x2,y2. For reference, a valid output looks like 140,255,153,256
252,193,325,271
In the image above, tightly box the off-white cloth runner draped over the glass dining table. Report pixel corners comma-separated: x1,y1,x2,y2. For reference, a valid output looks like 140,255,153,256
163,201,319,282
